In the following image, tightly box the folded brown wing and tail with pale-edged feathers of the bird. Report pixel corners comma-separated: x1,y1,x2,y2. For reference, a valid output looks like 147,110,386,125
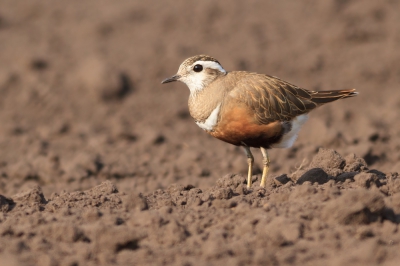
231,72,357,124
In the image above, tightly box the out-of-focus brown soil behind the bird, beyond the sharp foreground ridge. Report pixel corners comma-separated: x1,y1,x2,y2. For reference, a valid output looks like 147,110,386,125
0,0,400,195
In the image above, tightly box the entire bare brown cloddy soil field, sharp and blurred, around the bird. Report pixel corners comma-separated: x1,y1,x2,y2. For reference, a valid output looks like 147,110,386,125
0,0,400,266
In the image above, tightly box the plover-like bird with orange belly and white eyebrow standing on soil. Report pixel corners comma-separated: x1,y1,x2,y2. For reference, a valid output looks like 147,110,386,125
161,55,358,188
